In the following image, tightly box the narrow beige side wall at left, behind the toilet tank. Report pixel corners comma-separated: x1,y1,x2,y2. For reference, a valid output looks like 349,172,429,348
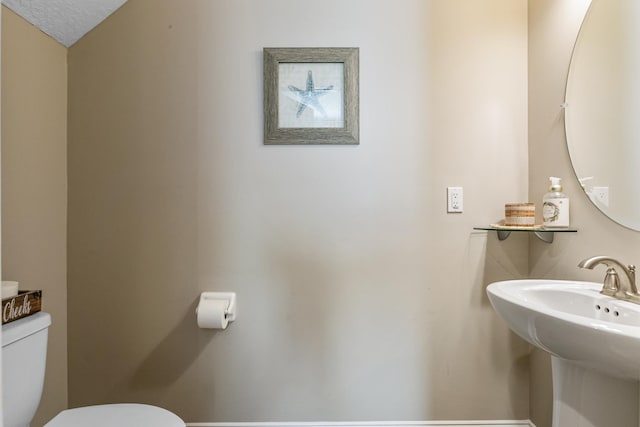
2,6,67,427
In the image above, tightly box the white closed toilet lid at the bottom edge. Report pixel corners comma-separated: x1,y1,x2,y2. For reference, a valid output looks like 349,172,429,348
44,403,185,427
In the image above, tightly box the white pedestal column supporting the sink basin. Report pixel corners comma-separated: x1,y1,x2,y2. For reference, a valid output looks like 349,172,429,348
551,358,640,427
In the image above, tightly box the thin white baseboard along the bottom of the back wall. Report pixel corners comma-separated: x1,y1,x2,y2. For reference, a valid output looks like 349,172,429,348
187,420,536,427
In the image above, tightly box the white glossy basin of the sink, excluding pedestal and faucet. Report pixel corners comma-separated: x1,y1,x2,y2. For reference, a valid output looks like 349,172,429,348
487,280,640,381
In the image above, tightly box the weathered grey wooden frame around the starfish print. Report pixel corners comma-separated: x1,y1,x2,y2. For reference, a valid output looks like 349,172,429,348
263,48,360,145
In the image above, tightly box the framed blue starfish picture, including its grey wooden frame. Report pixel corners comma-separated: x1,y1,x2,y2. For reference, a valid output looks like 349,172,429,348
263,48,359,145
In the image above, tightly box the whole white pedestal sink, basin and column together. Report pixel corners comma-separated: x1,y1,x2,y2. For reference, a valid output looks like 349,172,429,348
487,280,640,427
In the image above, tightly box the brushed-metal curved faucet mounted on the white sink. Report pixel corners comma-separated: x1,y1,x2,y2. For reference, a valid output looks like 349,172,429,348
578,256,640,304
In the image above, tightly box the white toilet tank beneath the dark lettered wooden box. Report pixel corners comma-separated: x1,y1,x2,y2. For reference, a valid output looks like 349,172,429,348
2,312,51,427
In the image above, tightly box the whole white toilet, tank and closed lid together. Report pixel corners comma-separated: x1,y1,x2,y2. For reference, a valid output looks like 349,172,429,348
2,312,185,427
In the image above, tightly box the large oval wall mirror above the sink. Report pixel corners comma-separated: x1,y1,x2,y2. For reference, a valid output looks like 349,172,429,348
565,0,640,230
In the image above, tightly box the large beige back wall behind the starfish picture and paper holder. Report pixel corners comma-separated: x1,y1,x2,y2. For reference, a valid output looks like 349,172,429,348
68,0,529,421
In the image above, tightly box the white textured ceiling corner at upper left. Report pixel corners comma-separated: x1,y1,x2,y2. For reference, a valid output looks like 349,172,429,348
2,0,127,47
